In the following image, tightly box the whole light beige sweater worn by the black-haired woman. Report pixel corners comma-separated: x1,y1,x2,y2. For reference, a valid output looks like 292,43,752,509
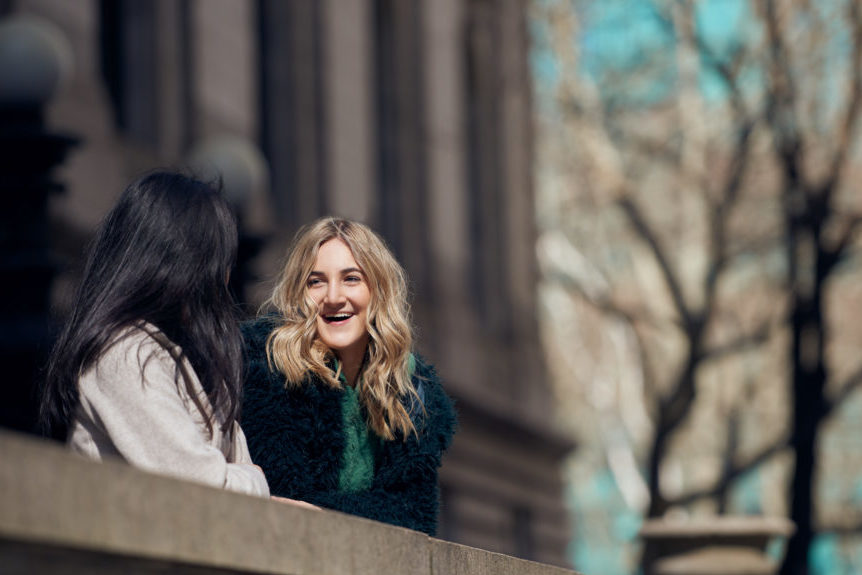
68,325,269,497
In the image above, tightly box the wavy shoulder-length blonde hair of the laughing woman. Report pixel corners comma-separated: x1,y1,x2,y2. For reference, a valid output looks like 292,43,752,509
266,217,421,440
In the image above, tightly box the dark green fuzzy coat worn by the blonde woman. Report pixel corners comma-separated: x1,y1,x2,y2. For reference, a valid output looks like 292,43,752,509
242,317,455,535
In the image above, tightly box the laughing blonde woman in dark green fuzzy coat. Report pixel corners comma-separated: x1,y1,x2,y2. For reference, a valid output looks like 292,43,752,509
242,218,455,534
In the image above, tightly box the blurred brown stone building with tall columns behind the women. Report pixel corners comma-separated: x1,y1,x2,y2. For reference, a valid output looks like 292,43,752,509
0,0,572,564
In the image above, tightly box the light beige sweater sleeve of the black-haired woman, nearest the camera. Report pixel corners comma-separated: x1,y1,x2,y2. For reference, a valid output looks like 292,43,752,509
73,335,269,496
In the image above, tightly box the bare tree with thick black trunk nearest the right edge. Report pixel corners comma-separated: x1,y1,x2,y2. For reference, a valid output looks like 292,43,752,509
759,0,862,575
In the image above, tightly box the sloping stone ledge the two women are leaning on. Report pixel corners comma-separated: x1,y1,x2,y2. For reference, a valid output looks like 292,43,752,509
0,431,574,575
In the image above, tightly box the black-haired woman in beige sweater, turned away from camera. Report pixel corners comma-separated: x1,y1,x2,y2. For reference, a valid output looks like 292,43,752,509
41,172,269,497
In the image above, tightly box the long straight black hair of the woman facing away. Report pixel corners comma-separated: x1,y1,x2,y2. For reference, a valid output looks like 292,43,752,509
40,171,242,439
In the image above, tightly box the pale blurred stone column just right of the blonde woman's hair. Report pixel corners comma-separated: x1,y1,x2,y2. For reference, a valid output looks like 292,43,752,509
422,0,482,390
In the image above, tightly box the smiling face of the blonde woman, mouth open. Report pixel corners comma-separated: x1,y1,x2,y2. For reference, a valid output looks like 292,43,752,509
306,238,371,367
